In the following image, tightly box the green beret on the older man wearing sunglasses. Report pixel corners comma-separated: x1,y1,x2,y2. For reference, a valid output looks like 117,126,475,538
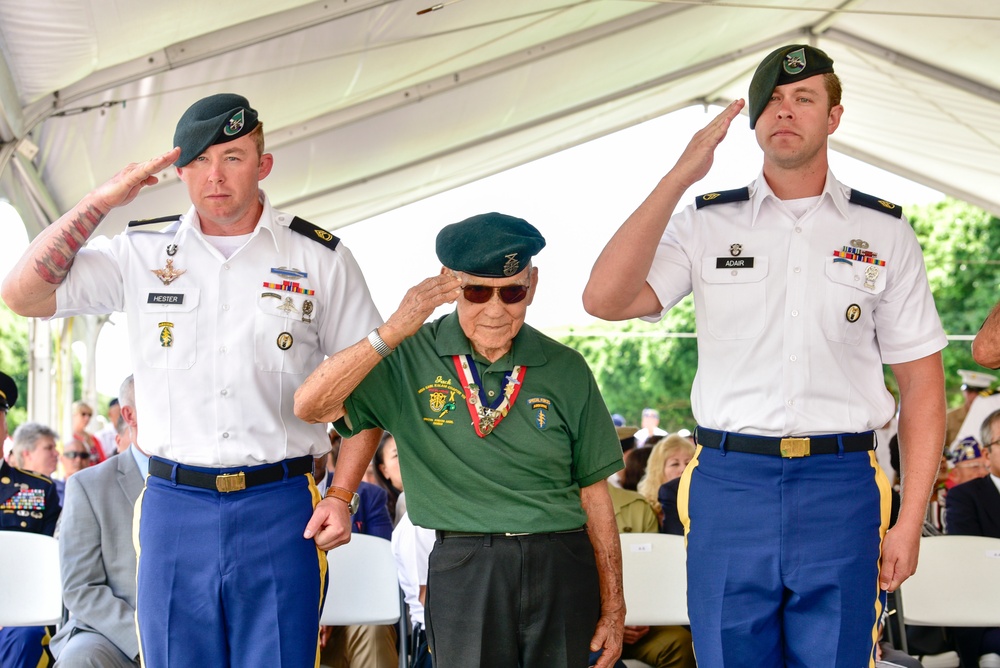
437,213,545,278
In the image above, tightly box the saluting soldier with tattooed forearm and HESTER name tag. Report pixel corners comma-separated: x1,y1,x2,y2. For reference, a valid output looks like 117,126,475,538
3,94,381,668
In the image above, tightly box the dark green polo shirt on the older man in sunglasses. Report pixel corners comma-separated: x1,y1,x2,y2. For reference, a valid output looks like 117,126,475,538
344,313,623,533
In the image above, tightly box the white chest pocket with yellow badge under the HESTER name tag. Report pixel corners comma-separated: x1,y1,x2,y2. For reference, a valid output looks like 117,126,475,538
139,288,201,369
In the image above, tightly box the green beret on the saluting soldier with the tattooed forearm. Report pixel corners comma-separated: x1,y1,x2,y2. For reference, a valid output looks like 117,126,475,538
174,93,257,167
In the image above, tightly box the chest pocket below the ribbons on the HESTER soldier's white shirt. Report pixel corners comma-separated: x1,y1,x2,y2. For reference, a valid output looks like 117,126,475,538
254,292,318,374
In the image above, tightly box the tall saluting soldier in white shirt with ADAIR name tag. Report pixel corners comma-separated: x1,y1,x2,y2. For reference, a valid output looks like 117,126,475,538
584,45,946,668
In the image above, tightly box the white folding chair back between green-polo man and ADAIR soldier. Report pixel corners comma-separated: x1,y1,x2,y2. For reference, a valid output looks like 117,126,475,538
620,533,690,668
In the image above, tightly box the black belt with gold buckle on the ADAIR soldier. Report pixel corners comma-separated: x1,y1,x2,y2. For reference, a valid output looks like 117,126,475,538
695,427,875,457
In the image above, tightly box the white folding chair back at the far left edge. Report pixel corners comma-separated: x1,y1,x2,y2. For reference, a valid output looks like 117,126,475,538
0,531,63,626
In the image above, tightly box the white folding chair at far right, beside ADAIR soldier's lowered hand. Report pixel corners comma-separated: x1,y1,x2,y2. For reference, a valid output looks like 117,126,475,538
896,536,1000,666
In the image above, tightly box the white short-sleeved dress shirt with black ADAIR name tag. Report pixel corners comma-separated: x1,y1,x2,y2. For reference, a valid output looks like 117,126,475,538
647,173,947,436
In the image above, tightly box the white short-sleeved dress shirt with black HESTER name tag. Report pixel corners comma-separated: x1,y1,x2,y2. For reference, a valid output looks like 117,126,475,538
55,193,382,467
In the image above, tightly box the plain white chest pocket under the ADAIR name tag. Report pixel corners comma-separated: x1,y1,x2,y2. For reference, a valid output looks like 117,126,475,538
701,257,767,340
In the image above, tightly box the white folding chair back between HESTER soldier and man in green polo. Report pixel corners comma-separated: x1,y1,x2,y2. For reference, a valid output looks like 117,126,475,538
320,533,401,626
